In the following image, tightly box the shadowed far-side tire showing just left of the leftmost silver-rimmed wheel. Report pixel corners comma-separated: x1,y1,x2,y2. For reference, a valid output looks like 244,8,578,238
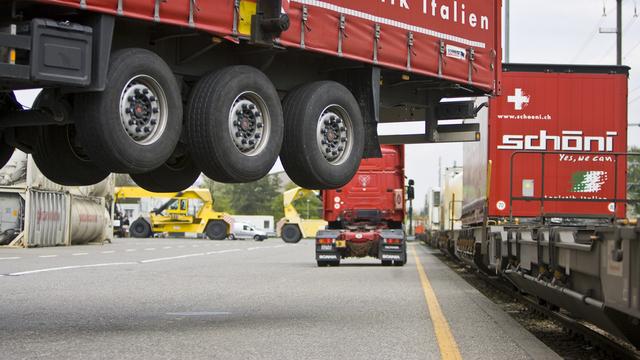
32,125,109,186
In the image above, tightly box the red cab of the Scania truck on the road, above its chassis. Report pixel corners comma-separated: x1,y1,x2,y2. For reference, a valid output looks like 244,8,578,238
322,145,405,222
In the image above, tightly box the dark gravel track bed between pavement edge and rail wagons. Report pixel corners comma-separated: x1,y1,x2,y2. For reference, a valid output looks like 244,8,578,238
436,248,640,360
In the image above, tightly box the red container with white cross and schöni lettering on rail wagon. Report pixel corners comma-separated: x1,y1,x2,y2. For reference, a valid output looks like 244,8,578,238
463,64,629,222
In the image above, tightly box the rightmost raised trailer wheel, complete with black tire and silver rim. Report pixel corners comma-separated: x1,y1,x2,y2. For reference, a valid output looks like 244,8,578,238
280,81,364,189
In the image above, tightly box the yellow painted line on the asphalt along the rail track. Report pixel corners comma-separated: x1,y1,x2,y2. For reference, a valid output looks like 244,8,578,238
411,246,462,360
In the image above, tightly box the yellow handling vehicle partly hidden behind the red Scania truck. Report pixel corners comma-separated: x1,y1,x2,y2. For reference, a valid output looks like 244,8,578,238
276,187,328,243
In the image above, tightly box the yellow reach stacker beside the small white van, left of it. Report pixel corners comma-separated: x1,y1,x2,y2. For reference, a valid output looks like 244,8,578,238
114,186,233,240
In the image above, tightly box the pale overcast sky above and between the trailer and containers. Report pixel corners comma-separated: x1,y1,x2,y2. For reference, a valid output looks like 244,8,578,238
11,0,640,210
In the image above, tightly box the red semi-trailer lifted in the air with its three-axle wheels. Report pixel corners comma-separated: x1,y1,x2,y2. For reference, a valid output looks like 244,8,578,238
0,0,501,191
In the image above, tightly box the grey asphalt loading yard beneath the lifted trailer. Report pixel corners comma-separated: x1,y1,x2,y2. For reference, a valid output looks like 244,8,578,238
0,239,557,359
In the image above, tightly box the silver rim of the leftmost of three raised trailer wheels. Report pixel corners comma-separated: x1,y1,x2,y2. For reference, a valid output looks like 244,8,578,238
120,75,169,145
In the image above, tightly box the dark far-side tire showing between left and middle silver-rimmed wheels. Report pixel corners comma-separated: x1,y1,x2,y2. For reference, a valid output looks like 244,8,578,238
130,143,200,192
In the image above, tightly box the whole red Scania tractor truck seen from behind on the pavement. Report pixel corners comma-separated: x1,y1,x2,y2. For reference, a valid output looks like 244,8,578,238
316,145,407,266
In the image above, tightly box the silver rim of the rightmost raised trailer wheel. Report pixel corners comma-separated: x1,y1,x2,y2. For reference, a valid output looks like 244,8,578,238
316,104,353,165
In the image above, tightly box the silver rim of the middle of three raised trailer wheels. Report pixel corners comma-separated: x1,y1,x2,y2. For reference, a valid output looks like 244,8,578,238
229,91,271,156
